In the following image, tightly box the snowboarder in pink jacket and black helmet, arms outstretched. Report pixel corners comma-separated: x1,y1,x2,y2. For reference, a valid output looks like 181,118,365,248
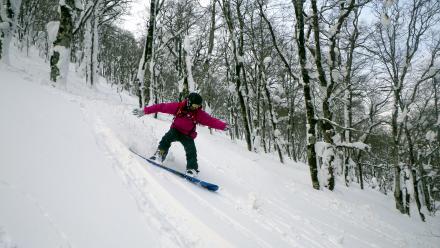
133,92,228,176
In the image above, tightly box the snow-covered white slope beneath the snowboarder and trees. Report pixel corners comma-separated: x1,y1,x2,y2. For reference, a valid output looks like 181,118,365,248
0,47,440,248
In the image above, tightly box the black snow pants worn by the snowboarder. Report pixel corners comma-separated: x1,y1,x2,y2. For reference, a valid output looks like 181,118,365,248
158,128,199,170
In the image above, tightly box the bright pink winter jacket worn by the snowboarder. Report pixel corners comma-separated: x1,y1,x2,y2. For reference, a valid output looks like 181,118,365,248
144,100,227,139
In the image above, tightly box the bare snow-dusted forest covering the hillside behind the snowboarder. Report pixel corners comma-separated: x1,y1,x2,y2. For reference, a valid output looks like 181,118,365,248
0,0,440,220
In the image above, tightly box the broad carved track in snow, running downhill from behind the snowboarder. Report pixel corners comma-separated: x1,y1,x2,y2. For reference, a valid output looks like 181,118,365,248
84,113,233,247
